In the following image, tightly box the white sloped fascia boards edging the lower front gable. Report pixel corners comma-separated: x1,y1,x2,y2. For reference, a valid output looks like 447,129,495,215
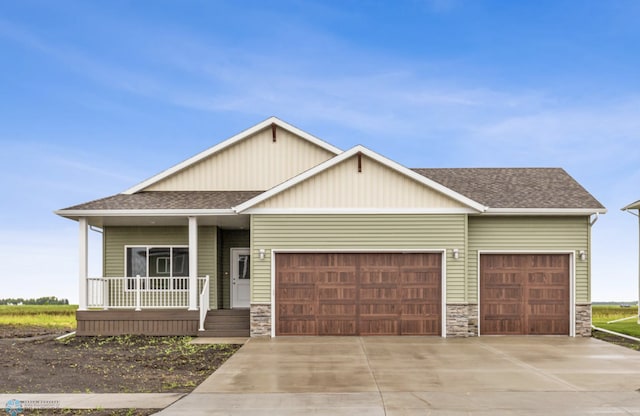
234,145,487,213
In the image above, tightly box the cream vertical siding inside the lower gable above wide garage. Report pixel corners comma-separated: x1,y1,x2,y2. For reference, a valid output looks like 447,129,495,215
255,156,467,209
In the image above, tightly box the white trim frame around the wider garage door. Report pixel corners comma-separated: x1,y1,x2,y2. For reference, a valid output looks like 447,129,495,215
264,248,447,338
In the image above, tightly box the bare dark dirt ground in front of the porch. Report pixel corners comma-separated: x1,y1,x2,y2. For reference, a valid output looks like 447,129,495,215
0,326,240,416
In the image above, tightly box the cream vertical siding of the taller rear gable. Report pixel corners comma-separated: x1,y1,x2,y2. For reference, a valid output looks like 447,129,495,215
144,127,335,191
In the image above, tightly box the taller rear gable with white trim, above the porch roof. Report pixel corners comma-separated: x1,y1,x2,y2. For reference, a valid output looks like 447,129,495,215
123,117,341,194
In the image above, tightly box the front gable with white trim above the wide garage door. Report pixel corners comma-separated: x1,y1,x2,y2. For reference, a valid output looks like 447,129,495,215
235,146,485,213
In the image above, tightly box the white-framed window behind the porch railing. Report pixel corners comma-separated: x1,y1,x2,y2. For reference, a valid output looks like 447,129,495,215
125,247,189,290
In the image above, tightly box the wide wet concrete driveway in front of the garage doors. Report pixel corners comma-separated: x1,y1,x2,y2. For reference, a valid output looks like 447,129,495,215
159,336,640,416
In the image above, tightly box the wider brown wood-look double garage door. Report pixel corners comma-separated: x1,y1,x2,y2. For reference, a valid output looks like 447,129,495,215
275,253,442,335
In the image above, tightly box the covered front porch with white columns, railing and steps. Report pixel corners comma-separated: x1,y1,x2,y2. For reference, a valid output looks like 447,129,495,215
77,214,251,336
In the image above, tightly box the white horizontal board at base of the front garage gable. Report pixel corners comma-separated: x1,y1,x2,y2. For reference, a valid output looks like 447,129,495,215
242,208,478,215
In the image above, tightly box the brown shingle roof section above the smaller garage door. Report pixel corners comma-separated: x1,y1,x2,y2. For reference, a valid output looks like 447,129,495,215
412,168,604,209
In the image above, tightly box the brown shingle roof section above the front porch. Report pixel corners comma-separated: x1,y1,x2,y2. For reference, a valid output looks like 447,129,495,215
63,191,262,211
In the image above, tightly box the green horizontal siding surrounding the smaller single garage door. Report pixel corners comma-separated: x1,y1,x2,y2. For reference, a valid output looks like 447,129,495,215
467,216,591,303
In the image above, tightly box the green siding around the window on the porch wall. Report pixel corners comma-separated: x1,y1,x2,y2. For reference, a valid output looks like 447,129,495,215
103,226,218,309
